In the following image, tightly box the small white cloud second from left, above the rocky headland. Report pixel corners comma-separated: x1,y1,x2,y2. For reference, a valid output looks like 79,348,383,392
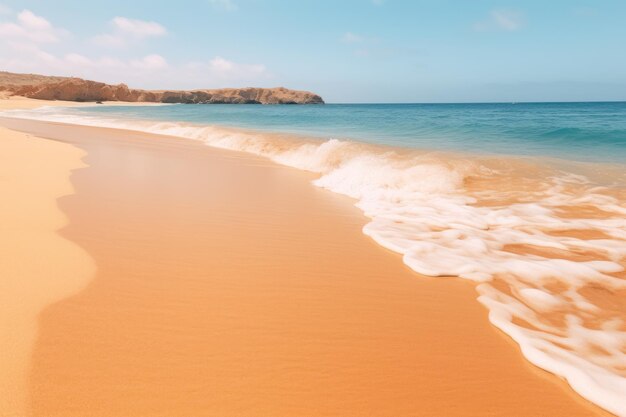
92,16,167,48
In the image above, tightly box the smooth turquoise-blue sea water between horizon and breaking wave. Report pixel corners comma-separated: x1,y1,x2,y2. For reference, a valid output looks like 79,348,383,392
72,102,626,163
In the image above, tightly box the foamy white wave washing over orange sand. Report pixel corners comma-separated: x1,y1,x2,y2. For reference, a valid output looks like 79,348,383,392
4,109,626,416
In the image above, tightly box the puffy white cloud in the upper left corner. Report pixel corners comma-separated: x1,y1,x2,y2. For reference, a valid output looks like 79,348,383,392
0,10,69,44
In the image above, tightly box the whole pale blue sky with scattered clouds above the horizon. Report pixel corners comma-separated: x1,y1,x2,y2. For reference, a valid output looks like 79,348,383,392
0,0,626,103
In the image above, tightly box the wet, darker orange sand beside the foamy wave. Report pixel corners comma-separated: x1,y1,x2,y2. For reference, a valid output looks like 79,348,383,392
3,105,604,416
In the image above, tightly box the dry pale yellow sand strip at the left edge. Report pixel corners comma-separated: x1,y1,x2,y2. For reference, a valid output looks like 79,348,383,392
0,109,95,417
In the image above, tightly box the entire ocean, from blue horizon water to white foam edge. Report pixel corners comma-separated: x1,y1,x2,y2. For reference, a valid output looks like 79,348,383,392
0,103,626,416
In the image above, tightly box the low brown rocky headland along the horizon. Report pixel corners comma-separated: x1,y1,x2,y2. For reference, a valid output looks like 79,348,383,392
0,71,324,104
